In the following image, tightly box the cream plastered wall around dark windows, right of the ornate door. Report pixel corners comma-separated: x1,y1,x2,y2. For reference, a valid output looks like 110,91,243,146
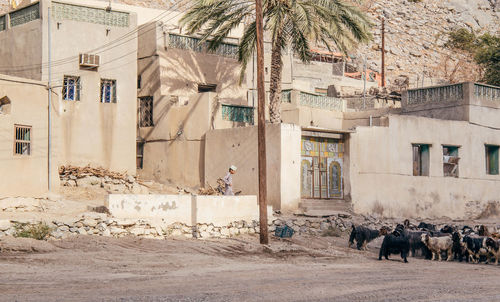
350,115,500,218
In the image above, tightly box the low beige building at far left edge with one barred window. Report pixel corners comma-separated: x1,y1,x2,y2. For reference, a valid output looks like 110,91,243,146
0,75,59,198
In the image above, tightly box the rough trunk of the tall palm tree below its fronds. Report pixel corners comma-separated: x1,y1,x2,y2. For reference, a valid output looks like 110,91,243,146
269,29,283,124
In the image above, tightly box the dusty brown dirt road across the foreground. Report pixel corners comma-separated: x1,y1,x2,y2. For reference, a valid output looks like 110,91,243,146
0,236,500,301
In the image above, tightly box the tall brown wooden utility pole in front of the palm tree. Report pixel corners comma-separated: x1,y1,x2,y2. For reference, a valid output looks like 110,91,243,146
255,0,269,244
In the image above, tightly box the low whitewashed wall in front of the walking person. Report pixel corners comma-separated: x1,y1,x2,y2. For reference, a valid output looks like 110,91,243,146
108,194,272,226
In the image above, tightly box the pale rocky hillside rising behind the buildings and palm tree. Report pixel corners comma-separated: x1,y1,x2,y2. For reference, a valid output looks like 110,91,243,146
0,0,500,86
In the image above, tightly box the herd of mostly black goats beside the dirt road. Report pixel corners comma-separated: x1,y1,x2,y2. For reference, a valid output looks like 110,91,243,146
349,220,500,265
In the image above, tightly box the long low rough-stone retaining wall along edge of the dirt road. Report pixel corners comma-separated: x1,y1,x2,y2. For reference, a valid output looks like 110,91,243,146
0,213,351,239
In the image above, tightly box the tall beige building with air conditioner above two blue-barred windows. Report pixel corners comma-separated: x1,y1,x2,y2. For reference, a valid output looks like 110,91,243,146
0,0,137,174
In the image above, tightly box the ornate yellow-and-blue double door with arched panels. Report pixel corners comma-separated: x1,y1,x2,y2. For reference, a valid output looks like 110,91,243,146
300,136,344,199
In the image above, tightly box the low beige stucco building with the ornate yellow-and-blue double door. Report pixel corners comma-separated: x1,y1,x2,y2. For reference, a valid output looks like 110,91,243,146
205,83,500,218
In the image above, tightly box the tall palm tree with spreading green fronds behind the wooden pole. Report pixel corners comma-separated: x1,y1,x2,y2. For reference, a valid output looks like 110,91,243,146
180,0,371,123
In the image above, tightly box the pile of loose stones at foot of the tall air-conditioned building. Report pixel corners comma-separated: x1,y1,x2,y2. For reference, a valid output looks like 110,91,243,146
59,166,149,194
